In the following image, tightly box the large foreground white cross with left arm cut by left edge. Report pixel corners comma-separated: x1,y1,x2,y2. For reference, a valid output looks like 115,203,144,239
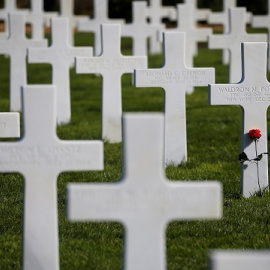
0,85,103,270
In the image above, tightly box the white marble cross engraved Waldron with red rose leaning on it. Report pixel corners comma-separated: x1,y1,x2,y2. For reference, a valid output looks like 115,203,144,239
209,42,270,197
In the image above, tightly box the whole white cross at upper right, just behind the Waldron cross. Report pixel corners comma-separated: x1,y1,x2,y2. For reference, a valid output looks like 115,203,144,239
208,8,267,83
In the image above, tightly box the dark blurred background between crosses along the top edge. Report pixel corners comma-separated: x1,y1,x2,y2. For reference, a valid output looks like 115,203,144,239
0,0,268,22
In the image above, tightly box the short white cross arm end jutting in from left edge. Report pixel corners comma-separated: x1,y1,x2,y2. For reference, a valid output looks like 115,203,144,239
0,112,20,138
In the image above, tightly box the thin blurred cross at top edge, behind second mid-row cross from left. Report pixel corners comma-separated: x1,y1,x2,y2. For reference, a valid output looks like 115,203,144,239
60,0,88,45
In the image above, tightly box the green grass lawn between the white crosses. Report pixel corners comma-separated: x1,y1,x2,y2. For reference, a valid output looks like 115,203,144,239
0,30,270,270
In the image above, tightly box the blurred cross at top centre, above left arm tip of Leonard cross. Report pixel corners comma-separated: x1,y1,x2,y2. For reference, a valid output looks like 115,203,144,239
121,1,165,55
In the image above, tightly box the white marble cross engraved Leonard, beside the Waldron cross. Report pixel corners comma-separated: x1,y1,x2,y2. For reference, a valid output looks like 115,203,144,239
134,32,215,165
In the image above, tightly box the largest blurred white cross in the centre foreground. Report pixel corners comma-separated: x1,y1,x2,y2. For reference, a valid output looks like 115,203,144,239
67,114,222,270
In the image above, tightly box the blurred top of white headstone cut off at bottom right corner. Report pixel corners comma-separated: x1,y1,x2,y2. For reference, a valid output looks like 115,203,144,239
210,250,270,270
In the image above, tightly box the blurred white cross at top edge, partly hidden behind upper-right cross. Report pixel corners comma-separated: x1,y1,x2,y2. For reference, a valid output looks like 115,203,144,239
208,0,252,65
